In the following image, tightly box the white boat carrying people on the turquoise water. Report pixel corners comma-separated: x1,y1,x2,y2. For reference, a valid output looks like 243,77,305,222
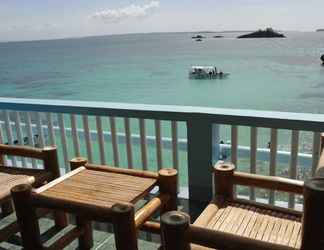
189,66,229,79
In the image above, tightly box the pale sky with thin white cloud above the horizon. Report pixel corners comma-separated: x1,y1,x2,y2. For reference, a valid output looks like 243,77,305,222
0,0,324,41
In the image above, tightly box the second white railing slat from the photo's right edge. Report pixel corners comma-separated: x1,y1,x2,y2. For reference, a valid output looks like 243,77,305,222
288,130,299,208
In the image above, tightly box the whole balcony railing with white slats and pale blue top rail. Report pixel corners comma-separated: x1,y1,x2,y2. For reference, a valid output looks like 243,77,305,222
0,98,324,208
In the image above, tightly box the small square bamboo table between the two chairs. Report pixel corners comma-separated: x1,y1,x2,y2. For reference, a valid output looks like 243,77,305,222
13,158,177,250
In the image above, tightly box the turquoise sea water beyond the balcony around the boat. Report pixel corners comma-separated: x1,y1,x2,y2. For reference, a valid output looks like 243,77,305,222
0,32,324,188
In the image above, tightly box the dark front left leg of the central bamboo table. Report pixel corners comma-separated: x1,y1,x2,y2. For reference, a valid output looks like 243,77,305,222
11,184,43,250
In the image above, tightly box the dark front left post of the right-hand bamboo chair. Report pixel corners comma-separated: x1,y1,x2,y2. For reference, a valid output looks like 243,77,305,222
161,211,190,250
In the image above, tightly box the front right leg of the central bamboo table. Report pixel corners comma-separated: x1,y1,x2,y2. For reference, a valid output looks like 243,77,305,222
112,204,138,250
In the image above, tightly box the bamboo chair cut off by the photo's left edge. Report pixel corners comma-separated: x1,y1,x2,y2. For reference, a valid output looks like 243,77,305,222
0,144,67,242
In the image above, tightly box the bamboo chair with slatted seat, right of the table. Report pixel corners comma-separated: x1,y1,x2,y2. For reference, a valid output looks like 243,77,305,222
161,163,324,250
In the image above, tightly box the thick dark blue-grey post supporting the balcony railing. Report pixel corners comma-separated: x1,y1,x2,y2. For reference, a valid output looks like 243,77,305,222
187,118,212,219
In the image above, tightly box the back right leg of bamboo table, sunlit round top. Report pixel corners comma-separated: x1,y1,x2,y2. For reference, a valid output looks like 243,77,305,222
159,168,178,214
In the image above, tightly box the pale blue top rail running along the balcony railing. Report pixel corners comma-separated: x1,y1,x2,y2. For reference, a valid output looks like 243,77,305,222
0,97,324,132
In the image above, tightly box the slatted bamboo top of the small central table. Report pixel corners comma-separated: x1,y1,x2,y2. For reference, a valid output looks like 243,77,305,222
38,167,157,208
